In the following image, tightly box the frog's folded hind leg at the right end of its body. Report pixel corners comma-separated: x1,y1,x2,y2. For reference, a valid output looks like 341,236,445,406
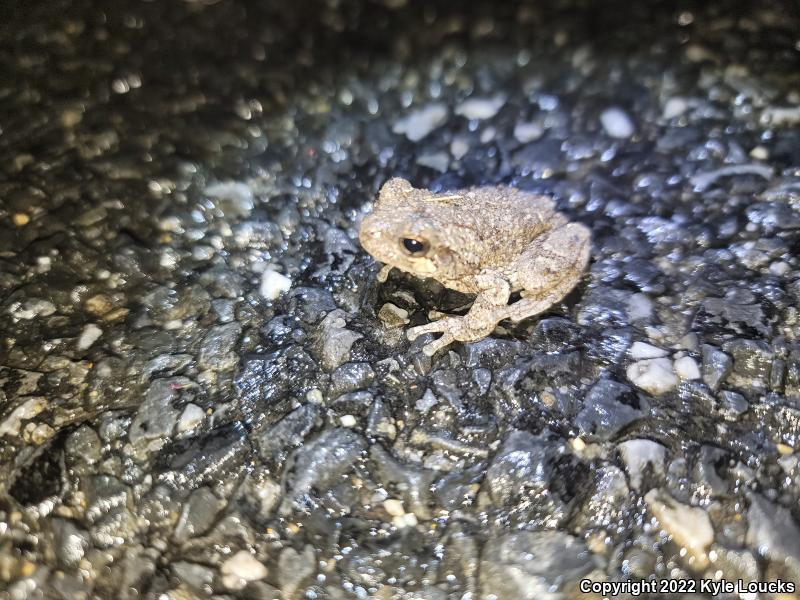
502,223,591,322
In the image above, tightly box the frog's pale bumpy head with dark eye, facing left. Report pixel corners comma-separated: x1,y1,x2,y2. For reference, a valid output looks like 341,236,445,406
358,178,476,282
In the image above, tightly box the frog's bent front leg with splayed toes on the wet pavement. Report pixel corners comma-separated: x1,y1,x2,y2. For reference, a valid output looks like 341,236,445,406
406,270,511,356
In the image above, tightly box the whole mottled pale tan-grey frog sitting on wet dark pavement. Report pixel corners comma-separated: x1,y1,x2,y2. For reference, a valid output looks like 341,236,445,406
359,178,591,355
